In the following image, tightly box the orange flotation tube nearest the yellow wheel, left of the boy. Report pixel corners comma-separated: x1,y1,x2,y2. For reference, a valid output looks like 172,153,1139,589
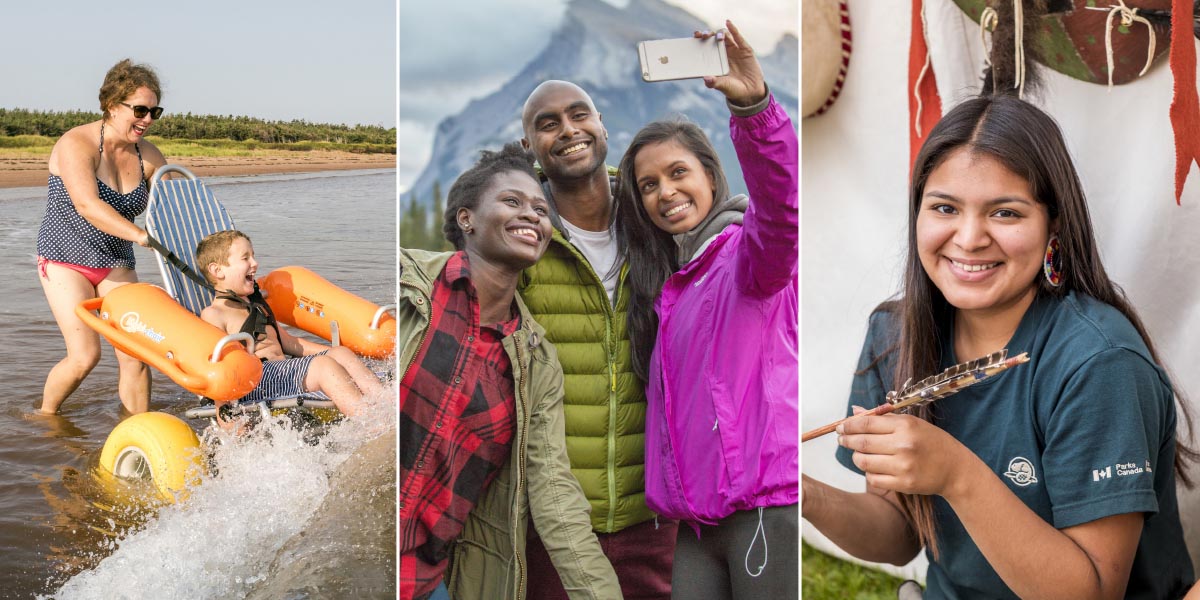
76,283,263,402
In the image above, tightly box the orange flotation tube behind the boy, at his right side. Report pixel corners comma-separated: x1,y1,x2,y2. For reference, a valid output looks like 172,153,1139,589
258,266,396,359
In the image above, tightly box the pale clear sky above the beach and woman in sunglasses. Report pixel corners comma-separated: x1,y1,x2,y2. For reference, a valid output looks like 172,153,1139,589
0,0,397,127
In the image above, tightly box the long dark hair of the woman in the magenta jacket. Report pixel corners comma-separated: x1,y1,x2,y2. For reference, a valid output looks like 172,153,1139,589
610,120,730,382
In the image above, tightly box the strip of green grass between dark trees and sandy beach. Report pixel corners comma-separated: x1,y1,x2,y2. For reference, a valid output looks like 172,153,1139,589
0,136,396,158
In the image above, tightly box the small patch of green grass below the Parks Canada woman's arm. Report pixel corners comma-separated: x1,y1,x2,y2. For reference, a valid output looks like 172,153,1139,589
800,540,904,600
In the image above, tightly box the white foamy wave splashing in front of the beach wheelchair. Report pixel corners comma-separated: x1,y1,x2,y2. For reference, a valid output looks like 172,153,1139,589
54,384,397,600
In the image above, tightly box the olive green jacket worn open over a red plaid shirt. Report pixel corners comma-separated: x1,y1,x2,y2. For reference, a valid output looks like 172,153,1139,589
397,248,620,600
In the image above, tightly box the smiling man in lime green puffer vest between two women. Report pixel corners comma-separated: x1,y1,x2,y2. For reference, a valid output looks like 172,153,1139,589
518,80,677,600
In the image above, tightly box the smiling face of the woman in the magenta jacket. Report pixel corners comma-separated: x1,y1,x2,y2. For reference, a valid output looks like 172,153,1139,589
634,139,714,235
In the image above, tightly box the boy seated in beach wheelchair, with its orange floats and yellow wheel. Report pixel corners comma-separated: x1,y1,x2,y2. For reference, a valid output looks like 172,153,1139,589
84,230,395,503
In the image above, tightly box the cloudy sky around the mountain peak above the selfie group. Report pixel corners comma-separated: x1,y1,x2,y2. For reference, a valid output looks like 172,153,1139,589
397,0,799,192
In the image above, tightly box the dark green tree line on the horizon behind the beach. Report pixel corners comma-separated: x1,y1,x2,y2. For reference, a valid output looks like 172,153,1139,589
0,108,396,146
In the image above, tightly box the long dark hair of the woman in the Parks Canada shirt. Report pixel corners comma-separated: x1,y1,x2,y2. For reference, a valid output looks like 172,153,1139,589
892,95,1198,557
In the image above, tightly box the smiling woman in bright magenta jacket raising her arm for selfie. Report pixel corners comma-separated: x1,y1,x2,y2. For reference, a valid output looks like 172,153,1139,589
614,23,799,599
